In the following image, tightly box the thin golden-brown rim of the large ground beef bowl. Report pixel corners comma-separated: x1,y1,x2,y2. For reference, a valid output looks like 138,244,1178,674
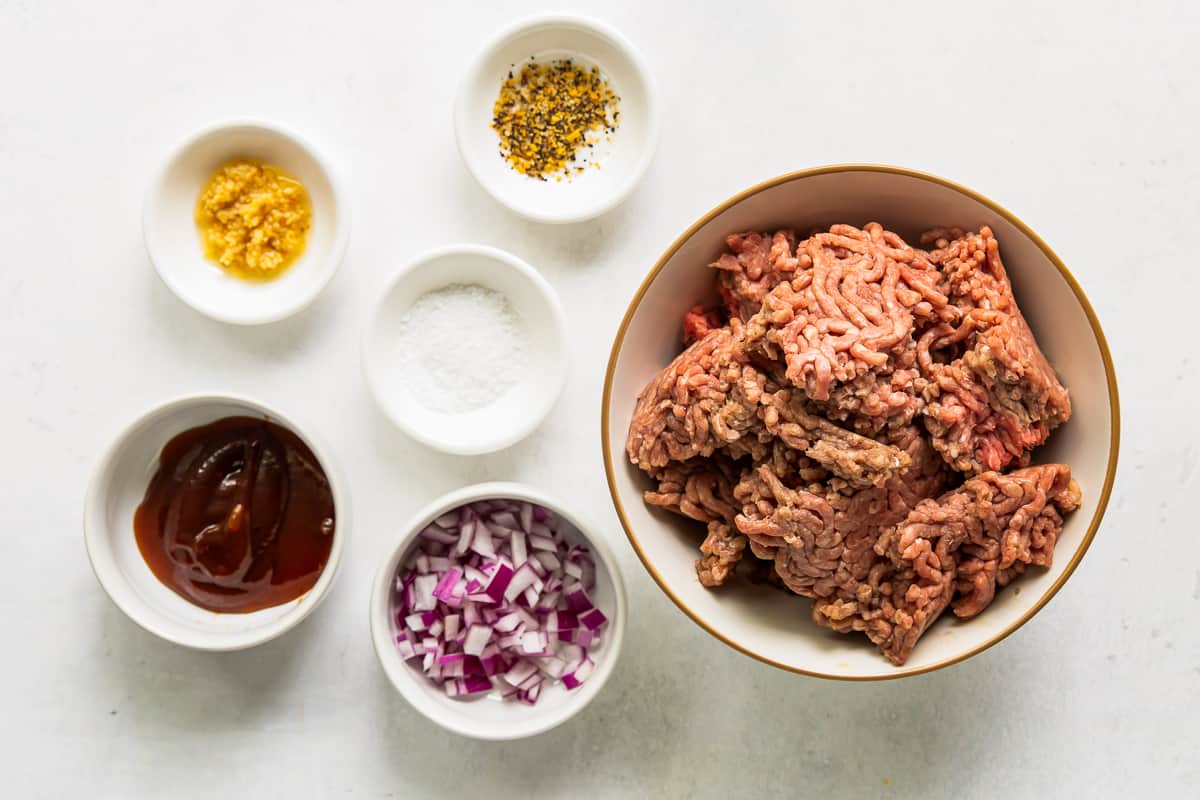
600,163,1121,681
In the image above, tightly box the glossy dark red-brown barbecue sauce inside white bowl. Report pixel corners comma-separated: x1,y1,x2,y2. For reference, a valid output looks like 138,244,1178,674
133,416,334,614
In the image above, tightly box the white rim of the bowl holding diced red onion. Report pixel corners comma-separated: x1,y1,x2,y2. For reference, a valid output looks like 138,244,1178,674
367,481,629,741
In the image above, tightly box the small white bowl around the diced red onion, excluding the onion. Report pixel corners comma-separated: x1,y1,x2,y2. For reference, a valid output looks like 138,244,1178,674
371,483,626,740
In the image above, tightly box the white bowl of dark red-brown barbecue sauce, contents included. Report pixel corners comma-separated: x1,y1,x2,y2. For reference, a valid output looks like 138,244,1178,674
84,395,349,650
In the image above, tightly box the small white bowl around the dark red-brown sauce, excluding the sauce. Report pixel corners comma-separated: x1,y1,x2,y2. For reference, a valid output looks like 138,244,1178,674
83,395,350,650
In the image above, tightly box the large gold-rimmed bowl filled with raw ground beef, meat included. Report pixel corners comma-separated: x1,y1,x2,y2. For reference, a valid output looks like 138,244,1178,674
602,167,1118,679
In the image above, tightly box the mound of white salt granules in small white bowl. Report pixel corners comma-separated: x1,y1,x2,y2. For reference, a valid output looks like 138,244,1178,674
397,283,528,414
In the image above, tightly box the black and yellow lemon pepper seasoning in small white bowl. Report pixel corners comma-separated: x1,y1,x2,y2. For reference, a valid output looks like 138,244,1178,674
492,59,620,181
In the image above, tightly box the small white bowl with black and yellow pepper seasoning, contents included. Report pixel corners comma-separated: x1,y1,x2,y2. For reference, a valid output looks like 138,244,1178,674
455,16,658,223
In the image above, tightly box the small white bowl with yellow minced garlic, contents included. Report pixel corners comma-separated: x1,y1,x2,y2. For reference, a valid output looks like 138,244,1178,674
142,121,350,325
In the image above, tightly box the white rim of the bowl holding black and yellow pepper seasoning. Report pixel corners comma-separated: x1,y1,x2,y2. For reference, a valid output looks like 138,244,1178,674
454,13,659,224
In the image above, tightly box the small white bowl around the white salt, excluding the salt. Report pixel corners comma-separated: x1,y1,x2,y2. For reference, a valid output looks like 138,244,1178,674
362,245,566,455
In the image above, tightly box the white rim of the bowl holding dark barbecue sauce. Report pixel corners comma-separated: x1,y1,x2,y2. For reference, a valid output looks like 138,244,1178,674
83,392,352,652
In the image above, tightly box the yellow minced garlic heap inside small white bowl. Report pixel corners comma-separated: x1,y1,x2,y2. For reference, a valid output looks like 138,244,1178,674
196,158,312,281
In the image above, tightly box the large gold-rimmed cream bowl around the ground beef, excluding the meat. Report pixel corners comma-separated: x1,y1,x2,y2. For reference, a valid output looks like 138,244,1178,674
601,164,1120,680
